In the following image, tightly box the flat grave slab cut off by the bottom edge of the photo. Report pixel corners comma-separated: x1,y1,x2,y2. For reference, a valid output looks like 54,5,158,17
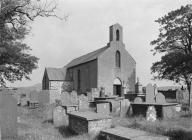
101,126,169,140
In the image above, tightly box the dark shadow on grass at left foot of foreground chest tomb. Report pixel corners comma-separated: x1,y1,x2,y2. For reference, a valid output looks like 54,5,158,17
56,126,78,138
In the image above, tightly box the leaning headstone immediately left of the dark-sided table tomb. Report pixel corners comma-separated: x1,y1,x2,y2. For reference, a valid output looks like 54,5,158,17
120,99,130,117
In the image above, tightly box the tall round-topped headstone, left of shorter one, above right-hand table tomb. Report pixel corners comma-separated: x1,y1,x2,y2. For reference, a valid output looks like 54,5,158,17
146,84,155,103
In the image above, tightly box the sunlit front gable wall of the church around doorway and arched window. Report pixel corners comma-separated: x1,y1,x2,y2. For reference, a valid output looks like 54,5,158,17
98,42,136,95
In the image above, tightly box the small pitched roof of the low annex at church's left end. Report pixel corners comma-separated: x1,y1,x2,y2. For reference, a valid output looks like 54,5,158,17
46,68,66,81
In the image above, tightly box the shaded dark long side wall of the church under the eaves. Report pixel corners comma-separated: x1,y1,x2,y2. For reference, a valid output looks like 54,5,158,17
66,60,97,93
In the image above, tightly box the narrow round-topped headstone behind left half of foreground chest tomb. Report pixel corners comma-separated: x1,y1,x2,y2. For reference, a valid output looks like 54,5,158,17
78,94,89,111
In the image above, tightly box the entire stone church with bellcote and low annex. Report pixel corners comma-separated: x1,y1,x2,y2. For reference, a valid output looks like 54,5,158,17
42,23,136,96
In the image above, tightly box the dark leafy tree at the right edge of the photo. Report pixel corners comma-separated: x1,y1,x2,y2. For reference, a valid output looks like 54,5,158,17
151,5,192,105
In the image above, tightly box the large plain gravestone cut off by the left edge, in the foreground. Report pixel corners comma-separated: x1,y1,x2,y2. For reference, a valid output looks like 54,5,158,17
0,91,17,139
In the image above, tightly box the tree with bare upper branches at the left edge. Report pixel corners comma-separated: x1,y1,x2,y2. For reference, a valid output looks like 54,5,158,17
0,0,65,86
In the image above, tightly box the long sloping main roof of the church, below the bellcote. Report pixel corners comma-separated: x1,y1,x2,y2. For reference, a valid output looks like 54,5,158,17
66,46,109,68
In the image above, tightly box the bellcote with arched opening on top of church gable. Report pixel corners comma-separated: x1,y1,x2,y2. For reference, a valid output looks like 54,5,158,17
109,23,123,42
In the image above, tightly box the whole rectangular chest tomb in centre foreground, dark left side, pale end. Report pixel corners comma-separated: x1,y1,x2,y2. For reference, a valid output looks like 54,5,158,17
68,112,112,134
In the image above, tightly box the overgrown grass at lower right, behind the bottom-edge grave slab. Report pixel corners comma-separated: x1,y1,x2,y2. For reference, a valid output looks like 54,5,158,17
113,116,192,140
